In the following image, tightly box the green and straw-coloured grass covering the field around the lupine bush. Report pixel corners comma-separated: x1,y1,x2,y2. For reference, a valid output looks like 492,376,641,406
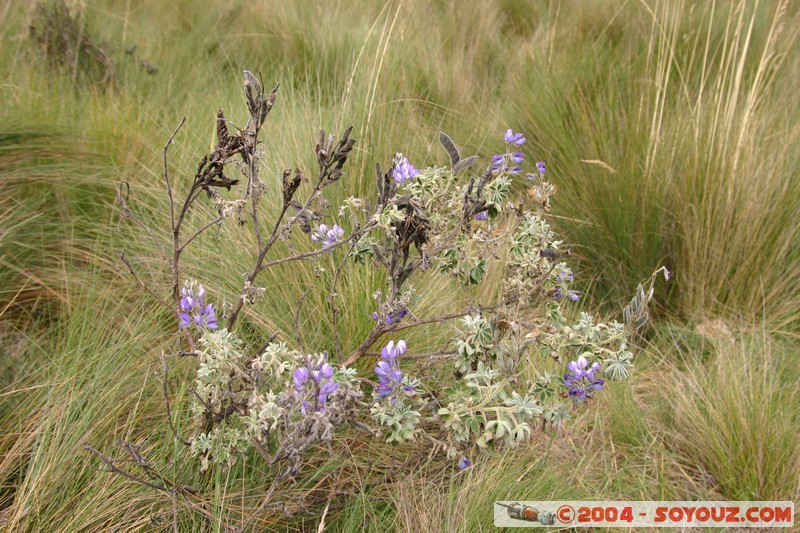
0,0,800,531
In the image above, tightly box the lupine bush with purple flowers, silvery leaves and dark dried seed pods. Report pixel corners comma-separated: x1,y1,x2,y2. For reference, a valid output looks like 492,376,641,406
87,71,668,524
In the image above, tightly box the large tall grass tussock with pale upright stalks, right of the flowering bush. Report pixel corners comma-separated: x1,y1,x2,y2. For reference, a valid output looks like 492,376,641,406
511,2,800,329
